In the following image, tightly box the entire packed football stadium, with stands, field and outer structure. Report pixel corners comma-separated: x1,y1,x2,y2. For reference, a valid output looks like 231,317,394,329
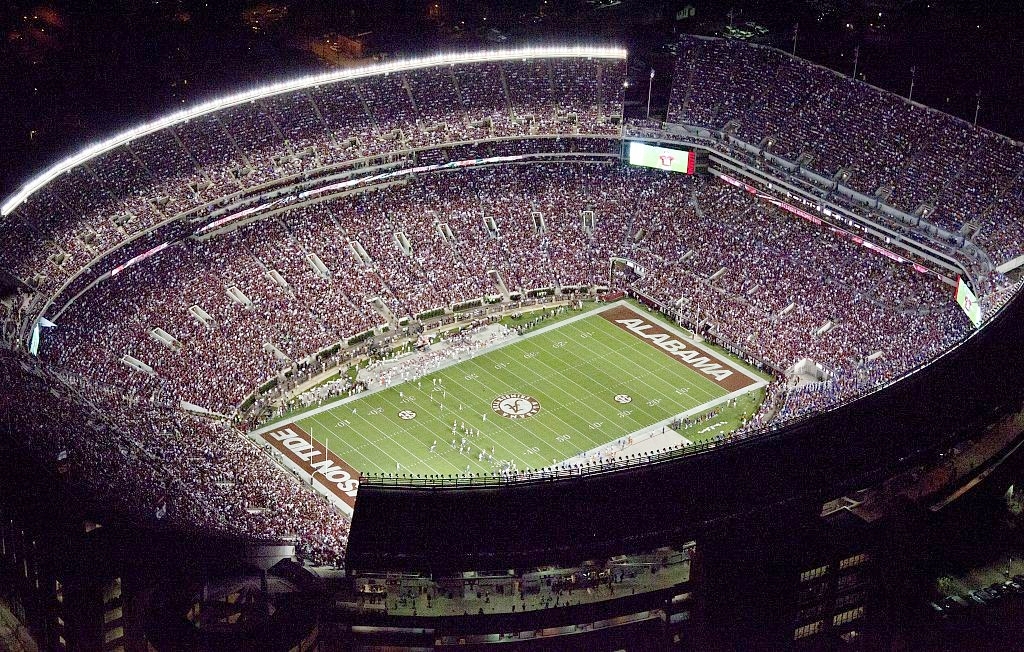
0,28,1024,649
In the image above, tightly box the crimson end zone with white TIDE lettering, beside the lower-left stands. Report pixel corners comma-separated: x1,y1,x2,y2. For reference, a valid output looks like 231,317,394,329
260,424,359,515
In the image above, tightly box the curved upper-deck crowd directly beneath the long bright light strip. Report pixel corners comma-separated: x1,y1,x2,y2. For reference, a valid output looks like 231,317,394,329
0,58,626,298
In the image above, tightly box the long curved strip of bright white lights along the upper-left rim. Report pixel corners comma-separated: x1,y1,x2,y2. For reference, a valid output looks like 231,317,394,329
0,45,627,216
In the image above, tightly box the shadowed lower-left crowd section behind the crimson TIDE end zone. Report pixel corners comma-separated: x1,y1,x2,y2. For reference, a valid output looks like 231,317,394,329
0,349,348,563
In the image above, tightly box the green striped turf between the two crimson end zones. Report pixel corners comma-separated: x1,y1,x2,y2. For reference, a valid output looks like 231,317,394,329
284,305,763,474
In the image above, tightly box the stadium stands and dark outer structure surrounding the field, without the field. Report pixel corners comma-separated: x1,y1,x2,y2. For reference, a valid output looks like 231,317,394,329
0,38,1024,649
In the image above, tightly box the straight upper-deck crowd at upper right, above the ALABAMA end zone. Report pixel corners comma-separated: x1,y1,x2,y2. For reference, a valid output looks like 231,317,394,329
668,37,1024,265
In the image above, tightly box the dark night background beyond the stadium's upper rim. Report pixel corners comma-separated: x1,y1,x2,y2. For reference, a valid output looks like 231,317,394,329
0,0,1024,195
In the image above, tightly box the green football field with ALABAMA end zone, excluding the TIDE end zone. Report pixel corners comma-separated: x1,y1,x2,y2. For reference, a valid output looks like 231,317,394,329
256,303,765,475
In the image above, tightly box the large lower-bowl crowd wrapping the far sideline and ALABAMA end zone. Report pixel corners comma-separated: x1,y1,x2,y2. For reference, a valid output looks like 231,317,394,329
41,164,991,427
